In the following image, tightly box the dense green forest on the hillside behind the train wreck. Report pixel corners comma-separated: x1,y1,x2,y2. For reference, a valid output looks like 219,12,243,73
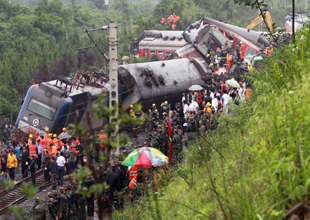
0,0,304,115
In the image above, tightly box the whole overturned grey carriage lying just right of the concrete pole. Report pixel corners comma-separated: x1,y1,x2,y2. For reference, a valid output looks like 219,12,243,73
118,58,212,109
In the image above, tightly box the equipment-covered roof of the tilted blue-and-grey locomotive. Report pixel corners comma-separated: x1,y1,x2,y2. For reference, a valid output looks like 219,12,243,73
39,74,109,97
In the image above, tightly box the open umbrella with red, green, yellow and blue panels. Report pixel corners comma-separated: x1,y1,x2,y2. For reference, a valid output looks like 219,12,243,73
123,147,168,168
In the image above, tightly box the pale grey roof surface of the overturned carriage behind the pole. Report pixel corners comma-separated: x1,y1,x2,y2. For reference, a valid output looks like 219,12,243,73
118,58,212,103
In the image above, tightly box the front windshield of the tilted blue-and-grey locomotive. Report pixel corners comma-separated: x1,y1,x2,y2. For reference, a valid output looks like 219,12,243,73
27,98,57,120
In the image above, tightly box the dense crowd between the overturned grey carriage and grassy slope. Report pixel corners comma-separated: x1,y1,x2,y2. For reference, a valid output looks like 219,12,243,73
130,75,252,163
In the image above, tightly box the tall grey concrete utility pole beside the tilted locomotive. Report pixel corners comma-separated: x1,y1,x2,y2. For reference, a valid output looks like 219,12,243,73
109,21,119,156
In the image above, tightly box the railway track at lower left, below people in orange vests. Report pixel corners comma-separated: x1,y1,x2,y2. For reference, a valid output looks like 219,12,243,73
0,170,51,215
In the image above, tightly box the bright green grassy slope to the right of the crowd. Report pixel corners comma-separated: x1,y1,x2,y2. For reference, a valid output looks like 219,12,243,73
113,30,310,219
